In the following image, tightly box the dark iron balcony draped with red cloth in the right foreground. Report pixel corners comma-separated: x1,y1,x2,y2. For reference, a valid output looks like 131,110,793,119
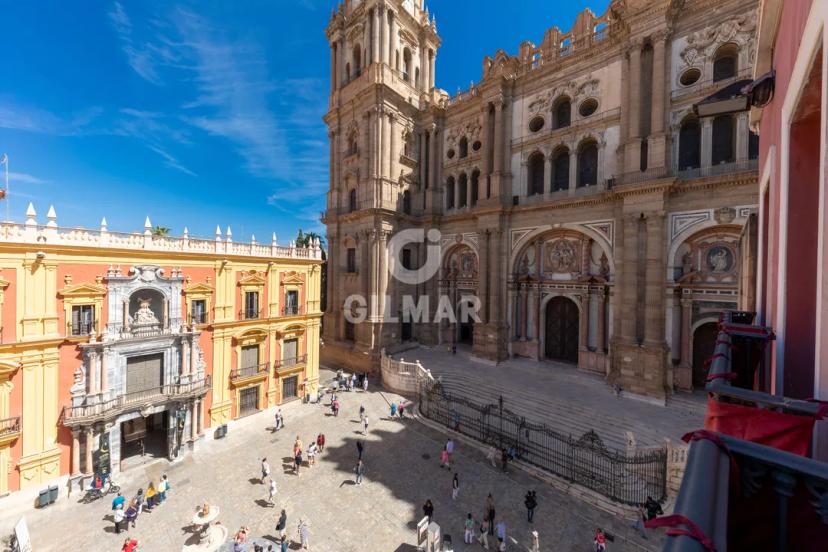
664,312,828,552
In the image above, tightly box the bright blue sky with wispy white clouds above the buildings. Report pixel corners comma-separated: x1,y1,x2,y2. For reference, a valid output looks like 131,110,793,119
0,0,608,243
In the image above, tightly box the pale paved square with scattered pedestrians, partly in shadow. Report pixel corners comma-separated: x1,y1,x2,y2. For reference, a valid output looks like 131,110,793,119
0,370,661,552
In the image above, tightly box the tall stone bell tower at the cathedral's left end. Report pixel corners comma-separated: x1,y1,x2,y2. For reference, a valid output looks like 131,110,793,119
324,0,440,370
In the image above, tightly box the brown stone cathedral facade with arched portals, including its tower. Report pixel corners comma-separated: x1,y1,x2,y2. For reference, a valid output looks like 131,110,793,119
322,0,758,401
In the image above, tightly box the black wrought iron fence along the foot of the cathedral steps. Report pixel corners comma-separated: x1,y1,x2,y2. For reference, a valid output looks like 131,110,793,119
419,379,667,504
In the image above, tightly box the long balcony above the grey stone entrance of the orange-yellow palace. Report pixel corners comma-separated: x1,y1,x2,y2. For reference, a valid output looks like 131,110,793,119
62,375,212,426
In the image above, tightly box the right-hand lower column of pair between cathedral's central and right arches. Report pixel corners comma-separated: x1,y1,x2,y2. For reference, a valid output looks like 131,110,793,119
644,213,665,347
